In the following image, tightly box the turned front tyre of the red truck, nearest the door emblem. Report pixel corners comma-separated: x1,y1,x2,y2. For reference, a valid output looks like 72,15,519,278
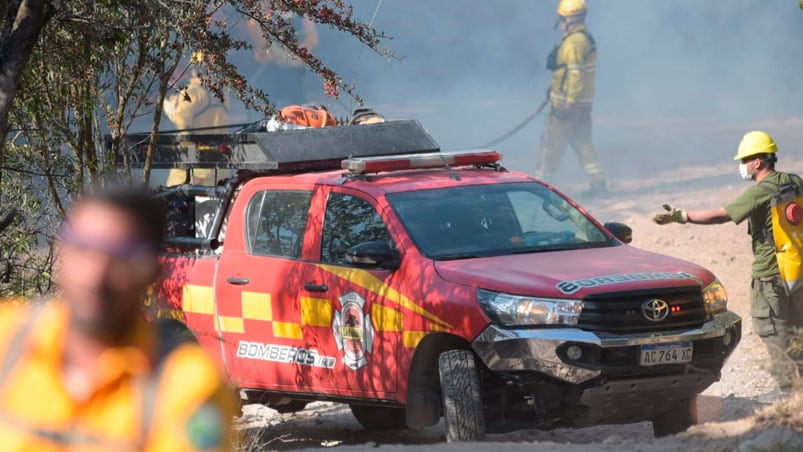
438,350,487,443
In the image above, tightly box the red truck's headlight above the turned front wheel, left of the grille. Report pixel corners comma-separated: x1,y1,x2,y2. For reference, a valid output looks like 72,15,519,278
477,289,583,326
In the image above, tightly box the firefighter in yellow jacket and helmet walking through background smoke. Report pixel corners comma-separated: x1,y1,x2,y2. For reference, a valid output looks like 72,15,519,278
535,0,607,196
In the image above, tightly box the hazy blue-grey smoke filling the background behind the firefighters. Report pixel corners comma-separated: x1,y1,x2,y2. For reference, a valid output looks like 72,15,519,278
159,0,803,186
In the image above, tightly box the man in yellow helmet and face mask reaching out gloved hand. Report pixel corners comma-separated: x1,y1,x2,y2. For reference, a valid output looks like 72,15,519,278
653,131,803,392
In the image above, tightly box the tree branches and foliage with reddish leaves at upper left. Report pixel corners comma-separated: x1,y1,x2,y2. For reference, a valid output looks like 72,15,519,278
0,0,388,295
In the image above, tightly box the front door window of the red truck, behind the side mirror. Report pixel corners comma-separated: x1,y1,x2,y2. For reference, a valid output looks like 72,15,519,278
321,193,393,264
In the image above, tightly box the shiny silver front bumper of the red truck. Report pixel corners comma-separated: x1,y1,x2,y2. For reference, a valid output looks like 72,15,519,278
472,311,741,384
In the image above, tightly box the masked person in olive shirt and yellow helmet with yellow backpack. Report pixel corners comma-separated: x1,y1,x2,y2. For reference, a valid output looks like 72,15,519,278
653,131,803,391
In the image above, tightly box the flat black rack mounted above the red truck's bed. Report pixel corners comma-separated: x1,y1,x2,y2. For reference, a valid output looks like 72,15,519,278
118,120,440,173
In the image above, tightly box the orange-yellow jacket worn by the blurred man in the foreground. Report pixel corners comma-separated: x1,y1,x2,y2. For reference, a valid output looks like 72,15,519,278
0,302,235,452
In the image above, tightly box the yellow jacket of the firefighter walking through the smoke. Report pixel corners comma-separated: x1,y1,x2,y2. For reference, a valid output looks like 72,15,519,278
547,25,597,109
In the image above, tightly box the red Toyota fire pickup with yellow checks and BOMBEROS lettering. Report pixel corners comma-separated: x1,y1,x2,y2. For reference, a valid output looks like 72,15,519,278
141,121,741,441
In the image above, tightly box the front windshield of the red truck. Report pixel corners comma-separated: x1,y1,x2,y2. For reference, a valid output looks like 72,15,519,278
386,182,613,260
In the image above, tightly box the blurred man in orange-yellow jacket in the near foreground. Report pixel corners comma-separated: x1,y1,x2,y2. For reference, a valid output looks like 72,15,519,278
0,187,236,451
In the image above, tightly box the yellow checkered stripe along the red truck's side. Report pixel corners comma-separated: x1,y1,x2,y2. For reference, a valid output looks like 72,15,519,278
182,284,448,348
